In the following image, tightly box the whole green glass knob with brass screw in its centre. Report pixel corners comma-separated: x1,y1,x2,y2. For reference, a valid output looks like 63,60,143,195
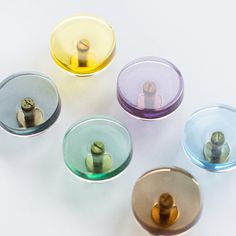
63,116,132,181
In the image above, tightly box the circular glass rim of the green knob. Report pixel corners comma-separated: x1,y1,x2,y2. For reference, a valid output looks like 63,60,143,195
63,116,133,182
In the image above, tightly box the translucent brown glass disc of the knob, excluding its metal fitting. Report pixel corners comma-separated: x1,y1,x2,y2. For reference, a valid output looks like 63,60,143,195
132,168,202,235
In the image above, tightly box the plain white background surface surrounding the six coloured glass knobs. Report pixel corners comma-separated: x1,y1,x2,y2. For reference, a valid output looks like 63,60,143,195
0,0,236,236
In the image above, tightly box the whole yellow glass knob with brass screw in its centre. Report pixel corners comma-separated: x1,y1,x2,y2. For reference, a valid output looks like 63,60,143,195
51,15,116,76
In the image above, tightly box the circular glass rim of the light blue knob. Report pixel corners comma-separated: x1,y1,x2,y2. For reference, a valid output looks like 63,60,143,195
182,104,236,172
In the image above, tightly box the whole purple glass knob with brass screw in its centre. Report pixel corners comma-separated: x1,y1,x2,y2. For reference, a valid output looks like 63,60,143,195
117,57,184,119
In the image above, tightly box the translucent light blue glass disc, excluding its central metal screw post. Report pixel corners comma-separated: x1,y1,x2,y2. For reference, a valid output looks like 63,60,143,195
183,105,236,171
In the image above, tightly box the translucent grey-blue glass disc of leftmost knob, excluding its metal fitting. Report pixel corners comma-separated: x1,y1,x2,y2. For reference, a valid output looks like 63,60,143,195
0,72,61,135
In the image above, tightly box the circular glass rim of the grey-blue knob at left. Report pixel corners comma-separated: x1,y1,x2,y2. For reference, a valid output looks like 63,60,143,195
0,71,61,136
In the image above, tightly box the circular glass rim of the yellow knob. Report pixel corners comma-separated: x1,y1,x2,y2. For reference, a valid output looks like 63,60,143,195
50,13,116,77
